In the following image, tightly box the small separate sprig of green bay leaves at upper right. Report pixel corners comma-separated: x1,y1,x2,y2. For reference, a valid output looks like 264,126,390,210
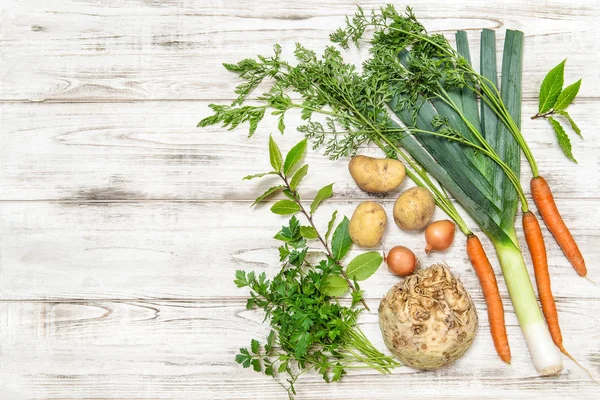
531,59,583,163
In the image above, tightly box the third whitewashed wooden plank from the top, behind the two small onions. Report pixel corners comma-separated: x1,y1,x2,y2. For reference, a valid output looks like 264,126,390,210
0,199,600,305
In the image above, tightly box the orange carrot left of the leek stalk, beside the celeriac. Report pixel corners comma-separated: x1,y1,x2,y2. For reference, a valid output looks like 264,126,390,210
467,234,511,364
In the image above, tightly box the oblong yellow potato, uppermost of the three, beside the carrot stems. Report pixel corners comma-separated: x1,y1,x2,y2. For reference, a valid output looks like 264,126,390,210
348,156,406,193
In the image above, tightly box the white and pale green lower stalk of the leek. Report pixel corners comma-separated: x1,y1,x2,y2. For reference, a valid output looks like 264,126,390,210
495,242,562,375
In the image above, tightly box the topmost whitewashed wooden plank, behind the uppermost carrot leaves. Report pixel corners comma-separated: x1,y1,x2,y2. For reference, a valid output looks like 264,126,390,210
0,0,600,101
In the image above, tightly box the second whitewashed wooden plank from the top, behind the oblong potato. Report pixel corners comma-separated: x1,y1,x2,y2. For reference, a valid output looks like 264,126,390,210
0,100,600,201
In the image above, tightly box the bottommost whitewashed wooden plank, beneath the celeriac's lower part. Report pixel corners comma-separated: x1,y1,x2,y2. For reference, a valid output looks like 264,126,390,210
0,298,600,400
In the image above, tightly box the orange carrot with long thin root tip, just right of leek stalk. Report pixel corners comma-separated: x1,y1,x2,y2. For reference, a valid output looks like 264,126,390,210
523,211,598,383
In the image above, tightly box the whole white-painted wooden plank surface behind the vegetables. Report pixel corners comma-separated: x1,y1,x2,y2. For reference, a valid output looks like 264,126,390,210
0,0,600,400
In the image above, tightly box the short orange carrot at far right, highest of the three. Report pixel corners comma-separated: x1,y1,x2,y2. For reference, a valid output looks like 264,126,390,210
531,176,587,276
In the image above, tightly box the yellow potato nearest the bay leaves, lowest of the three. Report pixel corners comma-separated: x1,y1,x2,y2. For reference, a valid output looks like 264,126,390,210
348,201,387,247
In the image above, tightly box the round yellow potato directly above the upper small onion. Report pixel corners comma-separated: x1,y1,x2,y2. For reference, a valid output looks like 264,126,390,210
394,187,435,231
